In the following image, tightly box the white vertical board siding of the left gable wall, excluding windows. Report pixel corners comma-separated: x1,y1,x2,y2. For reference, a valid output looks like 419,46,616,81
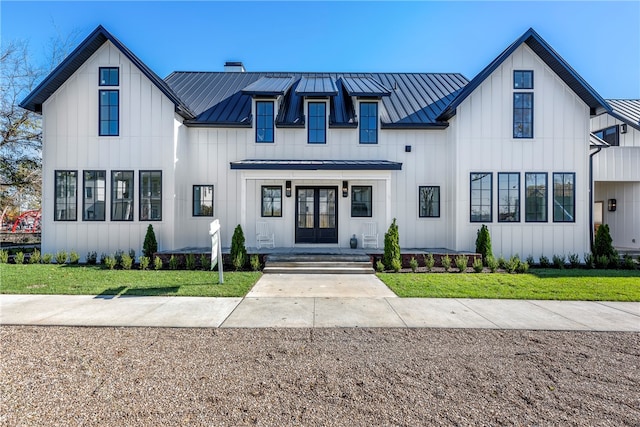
42,42,175,259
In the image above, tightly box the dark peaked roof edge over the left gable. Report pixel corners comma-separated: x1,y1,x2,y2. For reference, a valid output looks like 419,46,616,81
20,25,195,119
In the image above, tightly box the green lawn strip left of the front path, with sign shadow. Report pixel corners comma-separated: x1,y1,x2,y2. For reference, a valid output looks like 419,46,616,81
0,264,261,297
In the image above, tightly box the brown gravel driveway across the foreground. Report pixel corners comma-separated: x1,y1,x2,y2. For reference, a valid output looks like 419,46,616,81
0,326,640,426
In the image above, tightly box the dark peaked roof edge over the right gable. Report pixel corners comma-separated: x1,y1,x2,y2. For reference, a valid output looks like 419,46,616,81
438,28,610,120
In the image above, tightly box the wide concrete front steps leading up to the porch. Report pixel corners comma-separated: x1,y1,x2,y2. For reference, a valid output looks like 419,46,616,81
263,254,375,274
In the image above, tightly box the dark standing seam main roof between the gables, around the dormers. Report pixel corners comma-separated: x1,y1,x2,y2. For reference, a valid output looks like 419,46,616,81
165,72,468,129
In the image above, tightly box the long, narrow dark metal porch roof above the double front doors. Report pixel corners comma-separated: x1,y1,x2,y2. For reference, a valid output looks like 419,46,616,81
230,159,402,170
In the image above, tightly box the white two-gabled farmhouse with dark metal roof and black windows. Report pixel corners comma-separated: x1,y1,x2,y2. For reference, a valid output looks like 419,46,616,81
21,27,640,258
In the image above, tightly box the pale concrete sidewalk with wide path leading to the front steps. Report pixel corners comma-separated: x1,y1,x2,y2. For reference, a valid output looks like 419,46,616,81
0,274,640,332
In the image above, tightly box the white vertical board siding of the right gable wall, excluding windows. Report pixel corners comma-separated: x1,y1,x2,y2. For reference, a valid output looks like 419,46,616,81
449,44,589,259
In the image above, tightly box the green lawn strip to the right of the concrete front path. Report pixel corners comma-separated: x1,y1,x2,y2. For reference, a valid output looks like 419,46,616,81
378,269,640,301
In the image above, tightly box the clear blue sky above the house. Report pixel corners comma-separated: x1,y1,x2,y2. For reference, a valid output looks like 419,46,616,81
0,0,640,98
